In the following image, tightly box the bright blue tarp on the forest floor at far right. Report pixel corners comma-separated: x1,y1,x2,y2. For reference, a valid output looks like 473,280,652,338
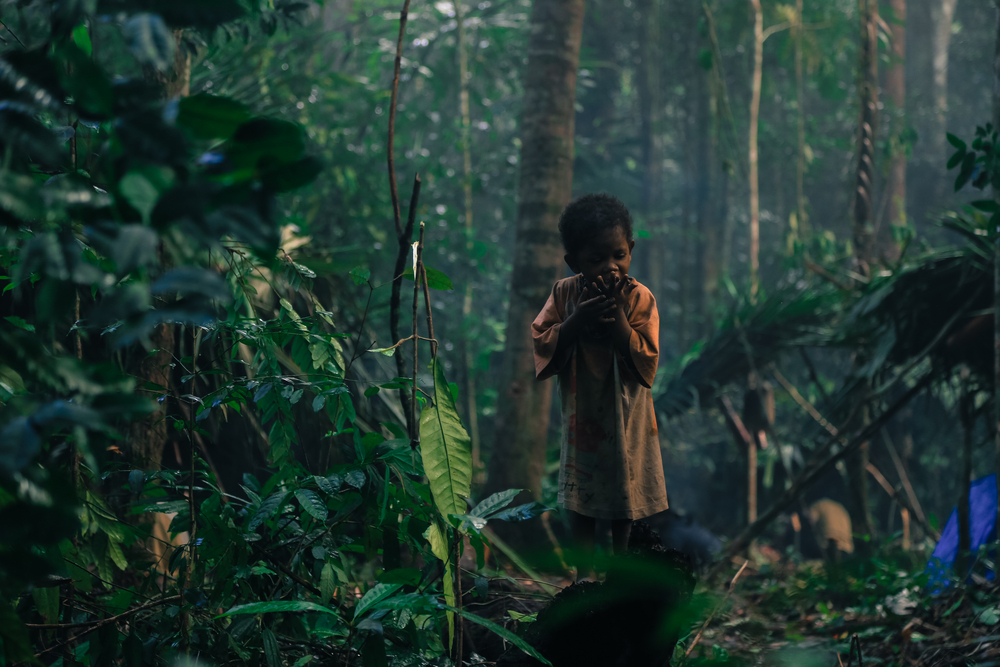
927,474,997,590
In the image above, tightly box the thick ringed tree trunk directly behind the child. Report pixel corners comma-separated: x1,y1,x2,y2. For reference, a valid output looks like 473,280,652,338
487,0,584,536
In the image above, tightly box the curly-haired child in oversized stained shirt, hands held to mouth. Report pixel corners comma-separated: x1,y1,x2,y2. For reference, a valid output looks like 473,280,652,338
531,194,667,578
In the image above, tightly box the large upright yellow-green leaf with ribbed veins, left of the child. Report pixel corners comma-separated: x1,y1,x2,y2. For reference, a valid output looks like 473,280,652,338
420,359,472,516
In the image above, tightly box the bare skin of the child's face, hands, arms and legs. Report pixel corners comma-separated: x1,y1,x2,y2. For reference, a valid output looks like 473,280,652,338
552,227,635,579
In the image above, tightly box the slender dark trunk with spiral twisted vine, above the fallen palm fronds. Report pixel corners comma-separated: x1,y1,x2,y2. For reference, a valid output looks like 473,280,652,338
847,0,878,548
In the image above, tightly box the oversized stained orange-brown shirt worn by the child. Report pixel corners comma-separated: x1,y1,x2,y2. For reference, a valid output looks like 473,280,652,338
531,275,667,520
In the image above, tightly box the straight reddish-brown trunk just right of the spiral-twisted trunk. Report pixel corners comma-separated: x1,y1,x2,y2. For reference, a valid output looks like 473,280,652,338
882,0,906,261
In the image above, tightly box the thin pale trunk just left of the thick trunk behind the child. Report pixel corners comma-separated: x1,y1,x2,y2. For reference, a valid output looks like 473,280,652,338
455,0,482,481
